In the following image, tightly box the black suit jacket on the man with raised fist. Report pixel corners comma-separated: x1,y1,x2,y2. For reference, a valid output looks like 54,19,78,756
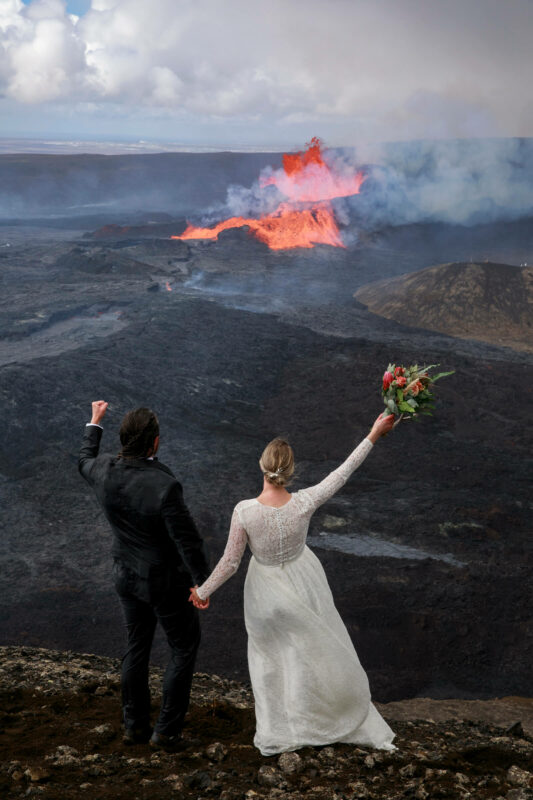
78,425,209,586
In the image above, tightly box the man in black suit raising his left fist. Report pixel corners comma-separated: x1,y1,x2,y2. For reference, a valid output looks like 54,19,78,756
78,400,209,752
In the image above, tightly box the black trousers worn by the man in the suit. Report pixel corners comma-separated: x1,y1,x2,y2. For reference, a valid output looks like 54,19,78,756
113,560,200,736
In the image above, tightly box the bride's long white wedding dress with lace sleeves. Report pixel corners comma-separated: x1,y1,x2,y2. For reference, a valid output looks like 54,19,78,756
198,439,395,755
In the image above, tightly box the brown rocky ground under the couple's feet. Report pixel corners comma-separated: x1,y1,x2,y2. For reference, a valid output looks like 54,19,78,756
0,647,533,800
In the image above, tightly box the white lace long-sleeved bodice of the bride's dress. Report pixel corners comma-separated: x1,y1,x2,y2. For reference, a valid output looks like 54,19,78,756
198,439,372,600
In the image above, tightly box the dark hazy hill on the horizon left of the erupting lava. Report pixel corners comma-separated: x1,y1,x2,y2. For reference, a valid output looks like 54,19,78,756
0,153,281,217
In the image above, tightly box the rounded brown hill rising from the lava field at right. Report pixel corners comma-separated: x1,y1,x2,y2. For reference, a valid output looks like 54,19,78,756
355,263,533,352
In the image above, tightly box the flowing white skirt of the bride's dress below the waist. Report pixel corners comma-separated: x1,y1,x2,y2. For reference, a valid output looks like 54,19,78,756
244,546,395,755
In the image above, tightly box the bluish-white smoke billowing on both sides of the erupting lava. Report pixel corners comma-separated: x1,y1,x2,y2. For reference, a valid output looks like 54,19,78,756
218,139,533,229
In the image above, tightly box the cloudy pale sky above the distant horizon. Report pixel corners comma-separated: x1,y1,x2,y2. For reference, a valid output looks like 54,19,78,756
0,0,533,149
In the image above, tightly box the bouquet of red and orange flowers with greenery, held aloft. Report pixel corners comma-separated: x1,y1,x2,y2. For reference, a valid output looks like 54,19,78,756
382,364,455,425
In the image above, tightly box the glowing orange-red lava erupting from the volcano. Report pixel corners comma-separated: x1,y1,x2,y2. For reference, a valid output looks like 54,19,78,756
171,137,365,250
